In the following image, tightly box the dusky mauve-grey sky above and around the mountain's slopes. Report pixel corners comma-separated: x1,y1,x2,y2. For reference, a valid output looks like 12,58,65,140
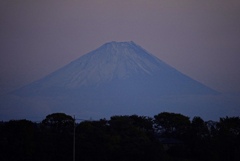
0,0,240,93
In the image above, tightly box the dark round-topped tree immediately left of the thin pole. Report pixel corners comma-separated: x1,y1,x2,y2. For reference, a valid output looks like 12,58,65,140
39,113,74,161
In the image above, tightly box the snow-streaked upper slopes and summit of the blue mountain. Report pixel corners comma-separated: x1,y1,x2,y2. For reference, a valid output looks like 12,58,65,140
61,42,171,88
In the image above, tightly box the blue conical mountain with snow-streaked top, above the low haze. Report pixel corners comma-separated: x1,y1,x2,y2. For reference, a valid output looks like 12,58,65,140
15,42,217,97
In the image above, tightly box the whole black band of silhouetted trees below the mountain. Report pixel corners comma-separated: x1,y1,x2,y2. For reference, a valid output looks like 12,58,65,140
0,112,240,161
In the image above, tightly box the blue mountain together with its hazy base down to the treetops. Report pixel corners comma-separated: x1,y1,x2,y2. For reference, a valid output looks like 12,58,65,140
1,41,240,119
